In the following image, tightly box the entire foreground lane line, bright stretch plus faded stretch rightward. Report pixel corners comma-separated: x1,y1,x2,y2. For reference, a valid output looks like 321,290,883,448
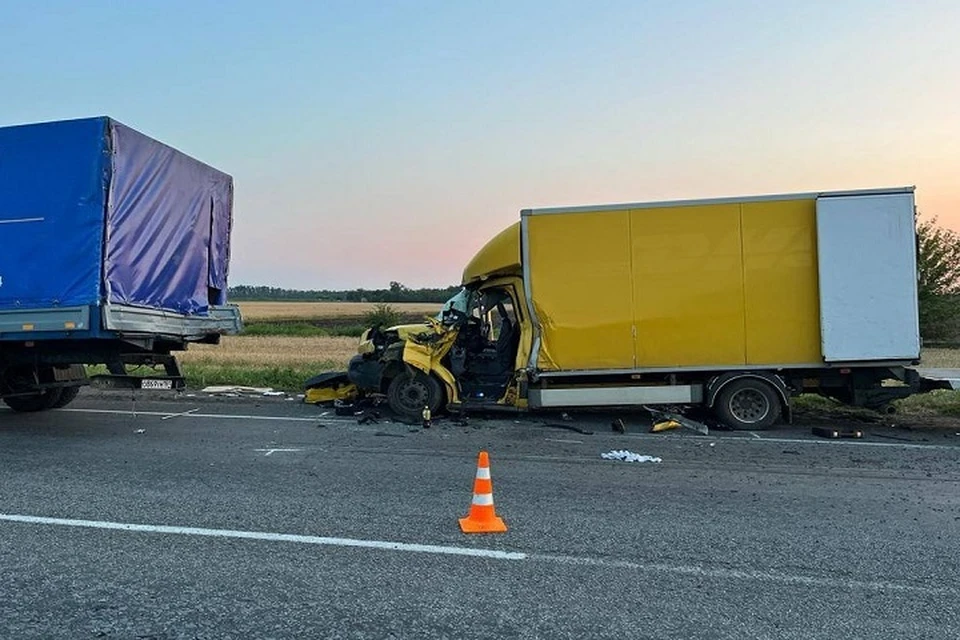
0,514,944,596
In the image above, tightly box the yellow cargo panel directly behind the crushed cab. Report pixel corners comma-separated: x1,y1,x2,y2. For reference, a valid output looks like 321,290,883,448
527,211,634,370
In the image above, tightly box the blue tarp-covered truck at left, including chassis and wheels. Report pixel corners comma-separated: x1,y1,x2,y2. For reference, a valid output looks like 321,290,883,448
0,117,242,411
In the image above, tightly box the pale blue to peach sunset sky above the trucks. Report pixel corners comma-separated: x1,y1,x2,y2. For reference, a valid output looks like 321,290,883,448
0,0,960,289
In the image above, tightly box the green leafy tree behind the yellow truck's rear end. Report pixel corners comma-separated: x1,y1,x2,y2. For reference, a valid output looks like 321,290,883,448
917,218,960,343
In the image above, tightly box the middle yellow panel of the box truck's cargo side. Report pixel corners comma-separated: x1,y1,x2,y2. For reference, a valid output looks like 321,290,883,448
630,204,746,367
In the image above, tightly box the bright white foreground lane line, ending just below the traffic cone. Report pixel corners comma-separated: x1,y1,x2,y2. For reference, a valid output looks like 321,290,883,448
0,514,527,560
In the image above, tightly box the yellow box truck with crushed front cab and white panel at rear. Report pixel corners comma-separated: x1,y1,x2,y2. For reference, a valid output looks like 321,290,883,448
348,187,921,429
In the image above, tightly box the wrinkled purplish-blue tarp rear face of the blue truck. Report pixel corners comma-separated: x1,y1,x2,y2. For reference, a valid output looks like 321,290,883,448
104,121,233,315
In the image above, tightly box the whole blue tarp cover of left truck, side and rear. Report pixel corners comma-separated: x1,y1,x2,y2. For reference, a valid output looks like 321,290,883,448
0,118,233,314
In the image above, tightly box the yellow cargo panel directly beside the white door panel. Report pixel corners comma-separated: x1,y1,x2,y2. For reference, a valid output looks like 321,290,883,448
742,199,820,365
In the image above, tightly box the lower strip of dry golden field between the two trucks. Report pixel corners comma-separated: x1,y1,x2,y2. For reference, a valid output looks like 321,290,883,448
178,336,357,373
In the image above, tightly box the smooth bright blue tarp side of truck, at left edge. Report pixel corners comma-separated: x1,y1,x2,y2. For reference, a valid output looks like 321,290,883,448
0,118,110,311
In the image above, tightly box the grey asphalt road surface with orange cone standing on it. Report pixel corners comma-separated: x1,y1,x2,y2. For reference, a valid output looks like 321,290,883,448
0,395,960,639
